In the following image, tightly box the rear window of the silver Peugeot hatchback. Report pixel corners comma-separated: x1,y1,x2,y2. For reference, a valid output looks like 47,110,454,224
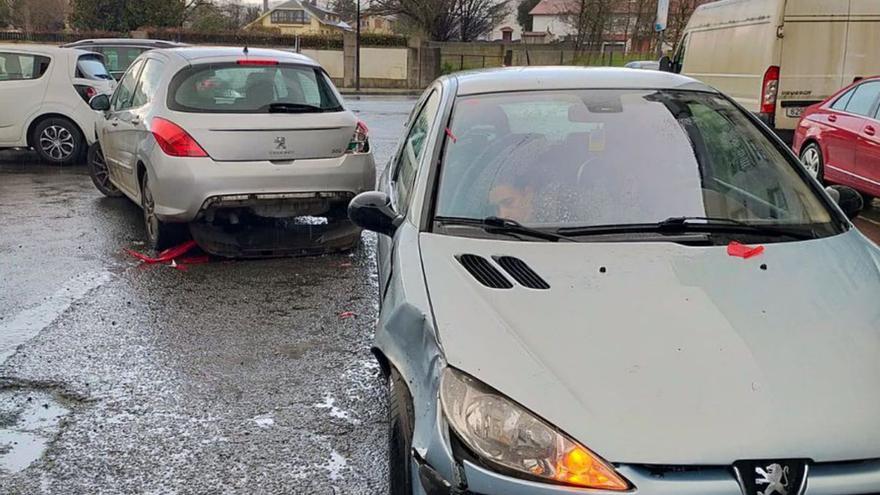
168,62,342,113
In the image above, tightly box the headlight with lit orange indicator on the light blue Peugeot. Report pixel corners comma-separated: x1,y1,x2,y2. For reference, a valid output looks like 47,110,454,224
440,368,630,491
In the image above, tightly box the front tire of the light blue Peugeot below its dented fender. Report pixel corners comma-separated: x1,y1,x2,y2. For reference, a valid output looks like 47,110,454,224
388,368,415,495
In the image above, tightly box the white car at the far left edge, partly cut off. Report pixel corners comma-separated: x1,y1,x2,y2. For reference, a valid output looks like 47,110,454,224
0,44,113,164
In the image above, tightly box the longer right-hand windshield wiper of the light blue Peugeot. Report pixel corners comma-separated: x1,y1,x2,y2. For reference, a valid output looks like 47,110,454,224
556,217,816,240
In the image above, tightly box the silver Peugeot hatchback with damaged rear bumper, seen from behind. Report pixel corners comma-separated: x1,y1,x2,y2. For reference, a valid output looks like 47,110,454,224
89,48,376,256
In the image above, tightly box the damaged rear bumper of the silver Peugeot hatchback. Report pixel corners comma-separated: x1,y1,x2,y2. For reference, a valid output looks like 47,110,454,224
147,147,376,222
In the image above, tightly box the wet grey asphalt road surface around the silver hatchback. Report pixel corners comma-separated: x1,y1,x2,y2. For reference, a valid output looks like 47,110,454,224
0,98,412,494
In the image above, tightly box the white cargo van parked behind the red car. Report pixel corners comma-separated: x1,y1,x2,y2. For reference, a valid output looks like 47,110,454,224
673,0,880,137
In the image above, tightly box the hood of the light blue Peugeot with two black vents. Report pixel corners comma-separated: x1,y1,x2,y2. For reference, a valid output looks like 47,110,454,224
420,231,880,465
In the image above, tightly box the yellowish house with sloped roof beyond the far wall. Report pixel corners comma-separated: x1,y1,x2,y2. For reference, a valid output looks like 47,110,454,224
245,0,351,35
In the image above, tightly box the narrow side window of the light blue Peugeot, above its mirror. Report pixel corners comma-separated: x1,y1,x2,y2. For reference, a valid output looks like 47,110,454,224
394,91,440,213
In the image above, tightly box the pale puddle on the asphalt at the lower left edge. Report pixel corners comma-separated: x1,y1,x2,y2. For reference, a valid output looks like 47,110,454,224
0,389,70,473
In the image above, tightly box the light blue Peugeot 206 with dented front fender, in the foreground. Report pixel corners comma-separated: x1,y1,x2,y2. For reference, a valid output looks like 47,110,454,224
349,67,880,495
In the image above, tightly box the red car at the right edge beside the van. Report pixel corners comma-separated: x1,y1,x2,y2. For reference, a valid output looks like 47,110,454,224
792,76,880,201
